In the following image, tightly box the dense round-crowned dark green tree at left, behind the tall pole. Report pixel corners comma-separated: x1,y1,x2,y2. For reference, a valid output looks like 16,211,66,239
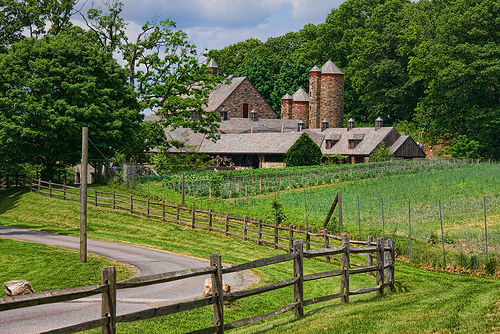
0,28,143,178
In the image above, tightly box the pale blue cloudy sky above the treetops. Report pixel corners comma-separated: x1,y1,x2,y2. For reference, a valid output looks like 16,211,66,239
74,0,344,51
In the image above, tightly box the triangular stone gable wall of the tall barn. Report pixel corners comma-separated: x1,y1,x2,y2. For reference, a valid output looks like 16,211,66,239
217,78,278,119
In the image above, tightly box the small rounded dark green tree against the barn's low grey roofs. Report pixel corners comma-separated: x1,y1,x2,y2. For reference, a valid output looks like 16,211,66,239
285,132,323,167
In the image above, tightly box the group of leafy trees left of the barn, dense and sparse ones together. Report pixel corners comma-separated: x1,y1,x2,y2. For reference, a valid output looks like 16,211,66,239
0,0,222,179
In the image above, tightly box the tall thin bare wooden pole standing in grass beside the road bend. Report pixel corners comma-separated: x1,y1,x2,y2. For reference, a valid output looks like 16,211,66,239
80,127,89,263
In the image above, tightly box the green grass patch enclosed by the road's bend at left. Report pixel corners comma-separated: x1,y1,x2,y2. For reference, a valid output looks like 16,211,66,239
0,238,134,298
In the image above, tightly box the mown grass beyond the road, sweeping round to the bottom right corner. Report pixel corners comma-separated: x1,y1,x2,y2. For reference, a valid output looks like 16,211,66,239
0,190,500,333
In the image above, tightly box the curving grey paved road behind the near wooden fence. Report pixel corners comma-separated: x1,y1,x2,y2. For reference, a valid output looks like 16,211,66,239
0,226,257,334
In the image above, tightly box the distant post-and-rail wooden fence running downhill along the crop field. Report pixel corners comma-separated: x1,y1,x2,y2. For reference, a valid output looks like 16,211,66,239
25,179,371,252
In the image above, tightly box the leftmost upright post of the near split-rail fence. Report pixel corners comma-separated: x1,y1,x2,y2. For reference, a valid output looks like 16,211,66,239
101,267,116,334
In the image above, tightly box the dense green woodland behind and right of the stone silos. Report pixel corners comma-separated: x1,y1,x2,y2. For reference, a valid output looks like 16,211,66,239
209,0,500,158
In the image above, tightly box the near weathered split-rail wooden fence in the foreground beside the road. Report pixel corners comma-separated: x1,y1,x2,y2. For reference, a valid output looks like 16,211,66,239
0,235,395,334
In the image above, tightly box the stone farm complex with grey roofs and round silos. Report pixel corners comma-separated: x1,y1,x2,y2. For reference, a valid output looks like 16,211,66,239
146,60,425,168
